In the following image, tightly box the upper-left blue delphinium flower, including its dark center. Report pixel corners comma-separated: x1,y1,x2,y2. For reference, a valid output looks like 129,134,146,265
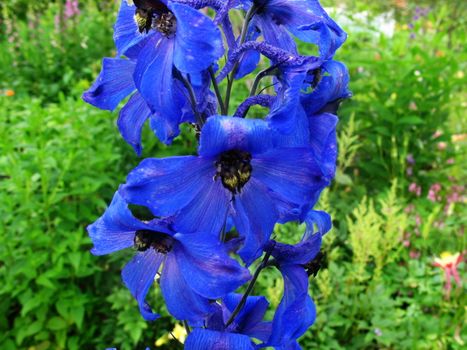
83,0,223,148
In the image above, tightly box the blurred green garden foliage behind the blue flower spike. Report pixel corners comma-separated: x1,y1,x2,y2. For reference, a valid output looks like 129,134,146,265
0,0,467,350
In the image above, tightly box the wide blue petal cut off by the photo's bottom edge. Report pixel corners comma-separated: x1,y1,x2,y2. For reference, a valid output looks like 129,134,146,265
185,328,255,350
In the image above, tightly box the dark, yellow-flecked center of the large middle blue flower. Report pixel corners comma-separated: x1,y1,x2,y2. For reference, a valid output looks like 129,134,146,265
214,150,253,194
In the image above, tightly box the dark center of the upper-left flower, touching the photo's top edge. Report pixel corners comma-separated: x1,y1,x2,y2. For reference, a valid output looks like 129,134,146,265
134,0,177,36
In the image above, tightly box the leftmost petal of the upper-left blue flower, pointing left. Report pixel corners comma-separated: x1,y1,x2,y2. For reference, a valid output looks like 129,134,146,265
83,58,135,111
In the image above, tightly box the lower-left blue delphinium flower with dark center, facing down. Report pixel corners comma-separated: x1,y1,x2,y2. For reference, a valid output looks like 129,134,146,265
88,192,250,325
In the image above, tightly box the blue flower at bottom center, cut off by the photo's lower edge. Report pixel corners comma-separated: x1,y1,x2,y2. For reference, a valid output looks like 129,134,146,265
185,293,272,350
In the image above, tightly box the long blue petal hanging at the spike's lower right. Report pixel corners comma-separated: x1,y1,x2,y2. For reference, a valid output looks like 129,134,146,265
268,265,316,346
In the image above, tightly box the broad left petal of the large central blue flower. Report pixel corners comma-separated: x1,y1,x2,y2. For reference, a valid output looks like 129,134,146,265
119,156,215,220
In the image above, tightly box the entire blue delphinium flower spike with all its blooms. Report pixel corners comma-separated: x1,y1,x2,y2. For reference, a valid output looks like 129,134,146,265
83,0,350,350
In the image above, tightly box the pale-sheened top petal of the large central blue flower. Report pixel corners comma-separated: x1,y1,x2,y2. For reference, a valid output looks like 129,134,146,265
198,116,272,156
